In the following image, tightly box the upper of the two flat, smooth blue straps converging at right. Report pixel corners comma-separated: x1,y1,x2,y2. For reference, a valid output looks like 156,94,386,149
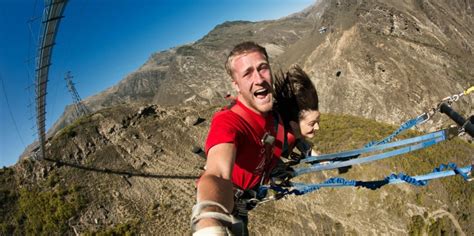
301,130,444,163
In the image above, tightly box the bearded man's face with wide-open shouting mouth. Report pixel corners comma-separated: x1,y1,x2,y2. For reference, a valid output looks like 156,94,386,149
231,52,273,114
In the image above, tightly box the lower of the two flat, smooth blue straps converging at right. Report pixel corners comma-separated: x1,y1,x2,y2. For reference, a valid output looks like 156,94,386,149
293,132,446,176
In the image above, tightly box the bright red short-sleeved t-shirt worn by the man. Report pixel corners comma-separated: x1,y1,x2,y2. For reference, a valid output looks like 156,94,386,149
205,100,279,190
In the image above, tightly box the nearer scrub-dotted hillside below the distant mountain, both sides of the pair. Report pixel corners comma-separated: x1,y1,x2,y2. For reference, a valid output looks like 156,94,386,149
0,102,474,235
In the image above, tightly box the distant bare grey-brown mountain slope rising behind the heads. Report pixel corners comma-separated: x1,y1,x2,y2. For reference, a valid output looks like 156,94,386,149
52,0,474,136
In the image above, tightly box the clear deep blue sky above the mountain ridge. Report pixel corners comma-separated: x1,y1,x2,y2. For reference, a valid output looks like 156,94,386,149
0,0,315,168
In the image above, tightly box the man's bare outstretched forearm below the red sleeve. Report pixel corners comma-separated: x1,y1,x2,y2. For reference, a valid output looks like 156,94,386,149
197,143,236,230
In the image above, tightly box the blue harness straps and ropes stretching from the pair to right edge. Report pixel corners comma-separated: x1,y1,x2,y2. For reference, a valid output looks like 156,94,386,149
257,87,474,204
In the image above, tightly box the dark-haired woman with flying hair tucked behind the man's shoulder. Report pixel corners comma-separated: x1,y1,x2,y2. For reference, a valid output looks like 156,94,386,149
274,64,320,164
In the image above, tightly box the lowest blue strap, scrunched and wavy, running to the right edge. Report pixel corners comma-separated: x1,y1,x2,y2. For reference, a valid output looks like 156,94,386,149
261,163,473,198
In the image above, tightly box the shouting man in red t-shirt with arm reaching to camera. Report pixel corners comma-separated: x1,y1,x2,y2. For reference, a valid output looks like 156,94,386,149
192,42,276,235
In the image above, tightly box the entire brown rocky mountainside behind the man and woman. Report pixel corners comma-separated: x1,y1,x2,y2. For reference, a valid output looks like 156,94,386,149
7,0,474,235
